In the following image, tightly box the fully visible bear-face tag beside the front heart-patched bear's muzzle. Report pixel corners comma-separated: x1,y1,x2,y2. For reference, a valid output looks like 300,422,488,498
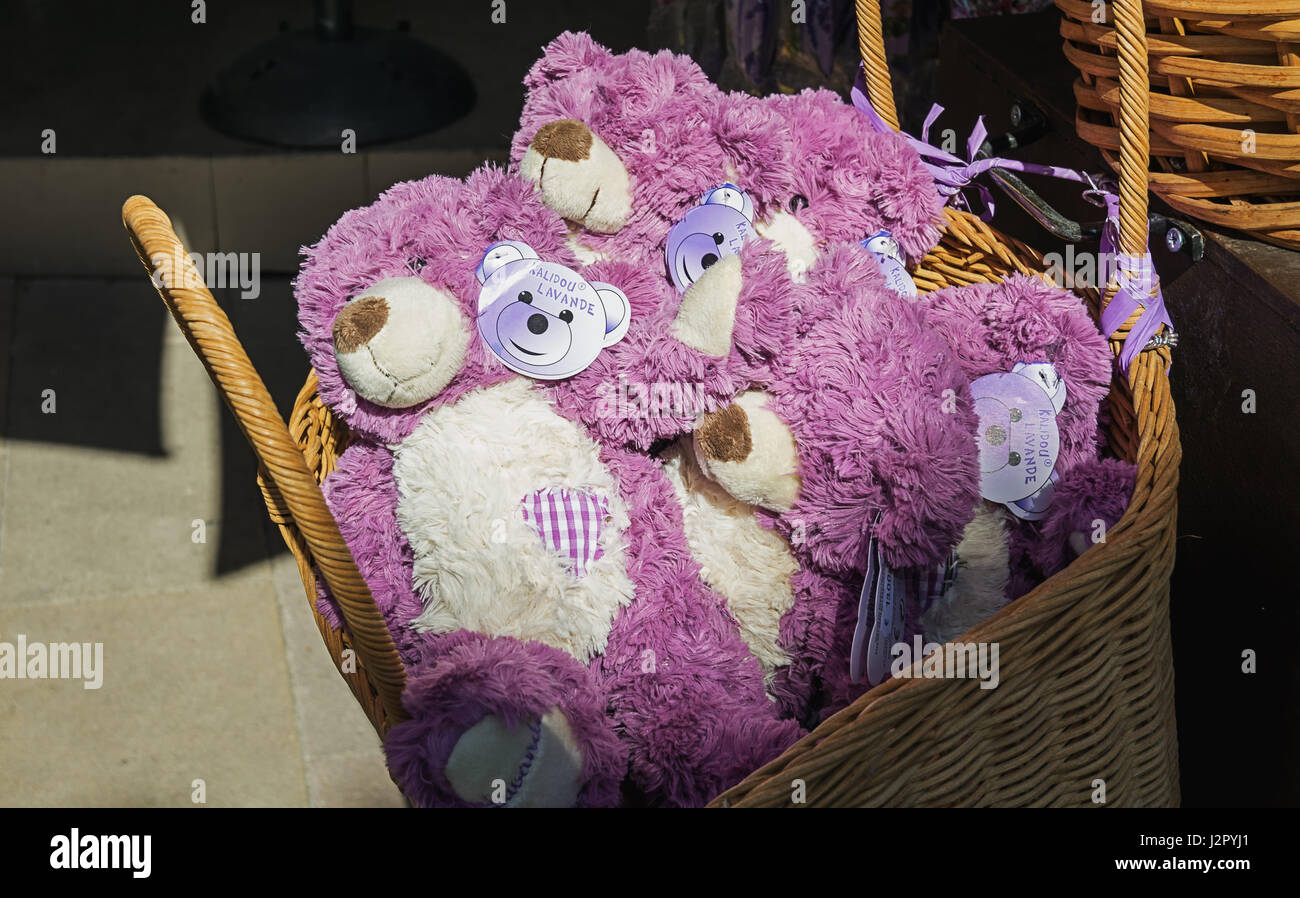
476,240,632,381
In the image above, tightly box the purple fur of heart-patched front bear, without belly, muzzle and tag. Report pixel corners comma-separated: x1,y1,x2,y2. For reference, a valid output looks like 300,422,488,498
296,161,802,804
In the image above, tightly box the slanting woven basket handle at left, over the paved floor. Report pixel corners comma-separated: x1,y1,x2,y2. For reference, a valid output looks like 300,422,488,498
122,196,407,724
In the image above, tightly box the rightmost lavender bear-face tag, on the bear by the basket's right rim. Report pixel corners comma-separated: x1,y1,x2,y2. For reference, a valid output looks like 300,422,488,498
971,361,1066,521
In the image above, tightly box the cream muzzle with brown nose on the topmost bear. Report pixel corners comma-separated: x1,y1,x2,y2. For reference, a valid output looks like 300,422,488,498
519,118,632,234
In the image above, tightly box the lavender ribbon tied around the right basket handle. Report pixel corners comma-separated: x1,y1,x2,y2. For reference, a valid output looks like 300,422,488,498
850,65,1174,374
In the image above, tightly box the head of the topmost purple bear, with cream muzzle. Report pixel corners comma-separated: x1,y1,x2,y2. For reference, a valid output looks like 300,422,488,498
511,32,790,266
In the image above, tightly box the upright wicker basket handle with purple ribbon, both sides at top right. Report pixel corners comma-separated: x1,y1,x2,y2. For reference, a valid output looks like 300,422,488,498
857,0,1151,256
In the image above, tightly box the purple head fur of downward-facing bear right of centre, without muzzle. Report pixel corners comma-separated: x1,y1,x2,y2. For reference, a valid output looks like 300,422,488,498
763,246,979,573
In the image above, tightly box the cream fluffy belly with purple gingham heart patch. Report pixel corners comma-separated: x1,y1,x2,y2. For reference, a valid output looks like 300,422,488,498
393,378,633,664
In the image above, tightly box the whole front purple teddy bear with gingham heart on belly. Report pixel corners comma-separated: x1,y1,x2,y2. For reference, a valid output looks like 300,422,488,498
295,168,802,806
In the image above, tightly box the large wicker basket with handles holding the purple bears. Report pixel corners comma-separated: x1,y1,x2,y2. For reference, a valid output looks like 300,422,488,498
124,0,1180,806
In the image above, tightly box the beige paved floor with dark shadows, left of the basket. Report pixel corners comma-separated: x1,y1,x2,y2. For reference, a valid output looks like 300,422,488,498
0,275,402,807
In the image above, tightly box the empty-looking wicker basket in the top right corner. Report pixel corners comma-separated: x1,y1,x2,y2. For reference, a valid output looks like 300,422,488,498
1056,0,1300,250
